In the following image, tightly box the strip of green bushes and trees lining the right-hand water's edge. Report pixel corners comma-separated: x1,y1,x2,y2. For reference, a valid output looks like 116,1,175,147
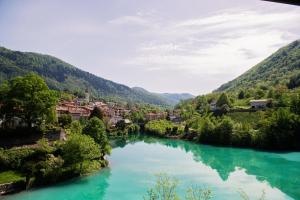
144,116,300,151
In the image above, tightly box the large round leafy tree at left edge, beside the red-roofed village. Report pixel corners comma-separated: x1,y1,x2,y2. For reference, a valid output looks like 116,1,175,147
0,73,58,128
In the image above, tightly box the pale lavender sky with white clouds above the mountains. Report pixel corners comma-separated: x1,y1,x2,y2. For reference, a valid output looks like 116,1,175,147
0,0,300,95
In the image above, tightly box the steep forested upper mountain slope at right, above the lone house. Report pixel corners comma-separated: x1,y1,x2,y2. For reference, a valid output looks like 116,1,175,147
216,40,300,92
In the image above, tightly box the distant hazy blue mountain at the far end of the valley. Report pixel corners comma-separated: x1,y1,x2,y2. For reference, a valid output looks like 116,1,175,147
132,87,194,105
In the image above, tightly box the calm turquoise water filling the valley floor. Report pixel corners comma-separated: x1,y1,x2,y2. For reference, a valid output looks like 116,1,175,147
2,137,300,200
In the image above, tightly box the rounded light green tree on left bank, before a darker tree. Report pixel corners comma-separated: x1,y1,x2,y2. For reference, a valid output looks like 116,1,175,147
62,134,101,172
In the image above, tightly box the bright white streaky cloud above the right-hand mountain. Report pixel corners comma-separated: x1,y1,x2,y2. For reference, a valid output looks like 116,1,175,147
125,7,300,81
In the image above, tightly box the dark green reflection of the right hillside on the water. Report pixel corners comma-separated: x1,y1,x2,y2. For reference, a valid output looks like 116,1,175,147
115,134,300,199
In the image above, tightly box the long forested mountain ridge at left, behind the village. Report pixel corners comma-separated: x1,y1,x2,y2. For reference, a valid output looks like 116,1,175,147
0,47,170,106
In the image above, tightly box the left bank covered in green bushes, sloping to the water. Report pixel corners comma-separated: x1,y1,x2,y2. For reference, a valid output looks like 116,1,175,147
0,135,108,194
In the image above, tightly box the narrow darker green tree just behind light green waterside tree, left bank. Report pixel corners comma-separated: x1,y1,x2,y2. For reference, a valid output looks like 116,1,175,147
82,117,111,156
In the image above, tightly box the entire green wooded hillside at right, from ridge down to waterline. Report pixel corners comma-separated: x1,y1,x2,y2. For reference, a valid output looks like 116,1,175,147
145,41,300,150
